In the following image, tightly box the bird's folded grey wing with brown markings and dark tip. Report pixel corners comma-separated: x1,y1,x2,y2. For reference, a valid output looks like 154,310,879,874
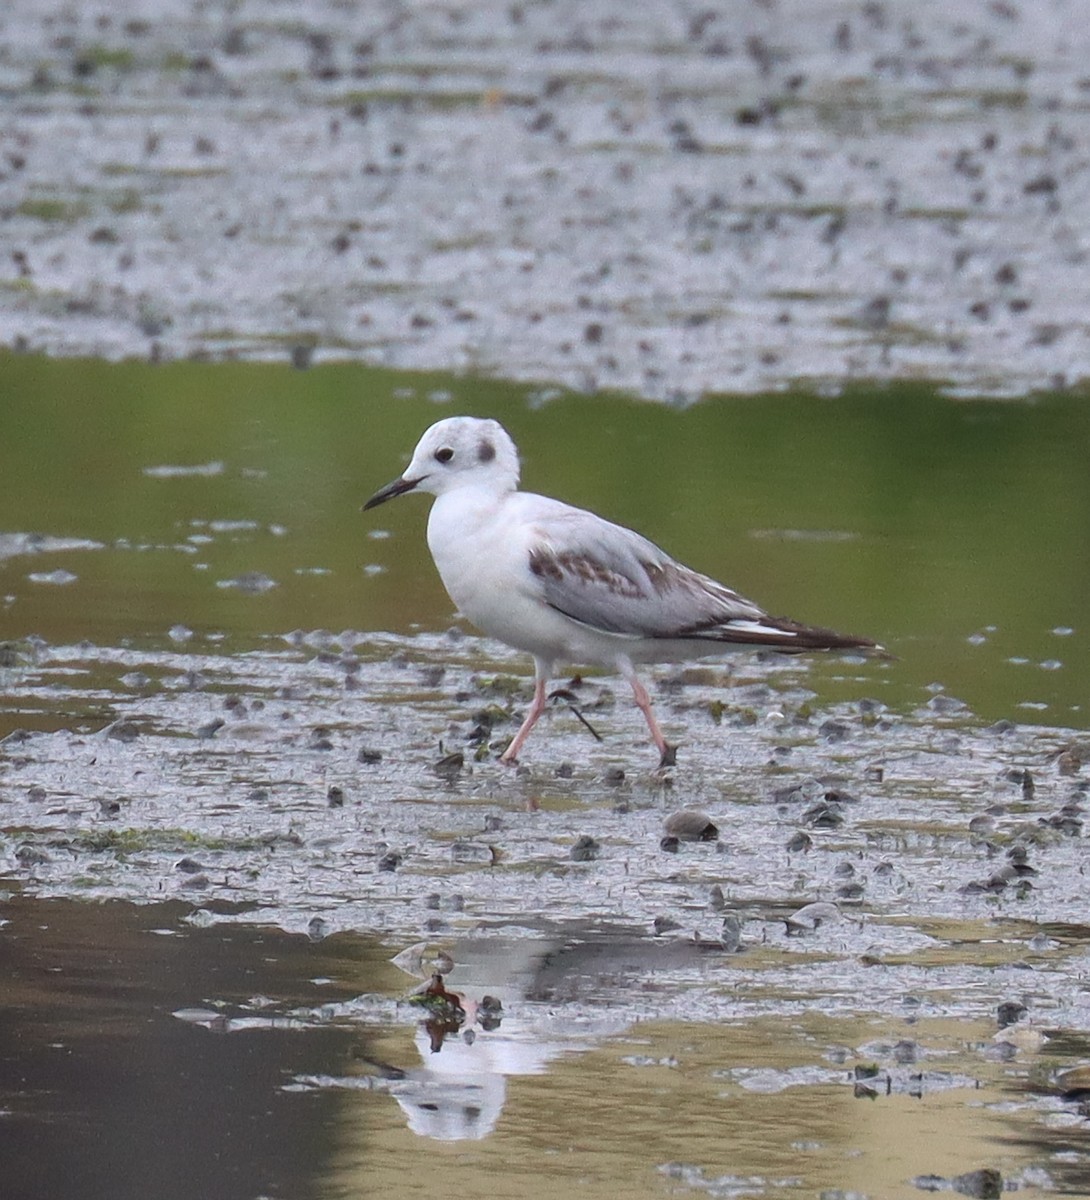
529,506,870,650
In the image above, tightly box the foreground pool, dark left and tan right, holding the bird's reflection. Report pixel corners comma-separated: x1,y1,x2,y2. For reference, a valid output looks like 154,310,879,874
0,896,1086,1200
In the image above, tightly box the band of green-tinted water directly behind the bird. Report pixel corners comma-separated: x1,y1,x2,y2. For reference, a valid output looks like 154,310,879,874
0,355,1090,726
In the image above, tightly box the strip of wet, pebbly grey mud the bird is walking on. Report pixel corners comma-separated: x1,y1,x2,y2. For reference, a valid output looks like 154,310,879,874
0,635,1090,1022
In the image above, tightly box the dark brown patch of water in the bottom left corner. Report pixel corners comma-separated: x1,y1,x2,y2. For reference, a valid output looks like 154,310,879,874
0,899,369,1200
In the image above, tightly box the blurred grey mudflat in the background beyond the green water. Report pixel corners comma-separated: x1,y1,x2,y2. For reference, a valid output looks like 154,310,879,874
0,0,1090,403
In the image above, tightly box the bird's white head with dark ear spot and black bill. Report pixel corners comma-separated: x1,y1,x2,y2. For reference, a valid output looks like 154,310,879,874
364,416,519,509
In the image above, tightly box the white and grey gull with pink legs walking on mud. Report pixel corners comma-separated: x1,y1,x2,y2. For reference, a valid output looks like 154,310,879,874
363,416,881,767
